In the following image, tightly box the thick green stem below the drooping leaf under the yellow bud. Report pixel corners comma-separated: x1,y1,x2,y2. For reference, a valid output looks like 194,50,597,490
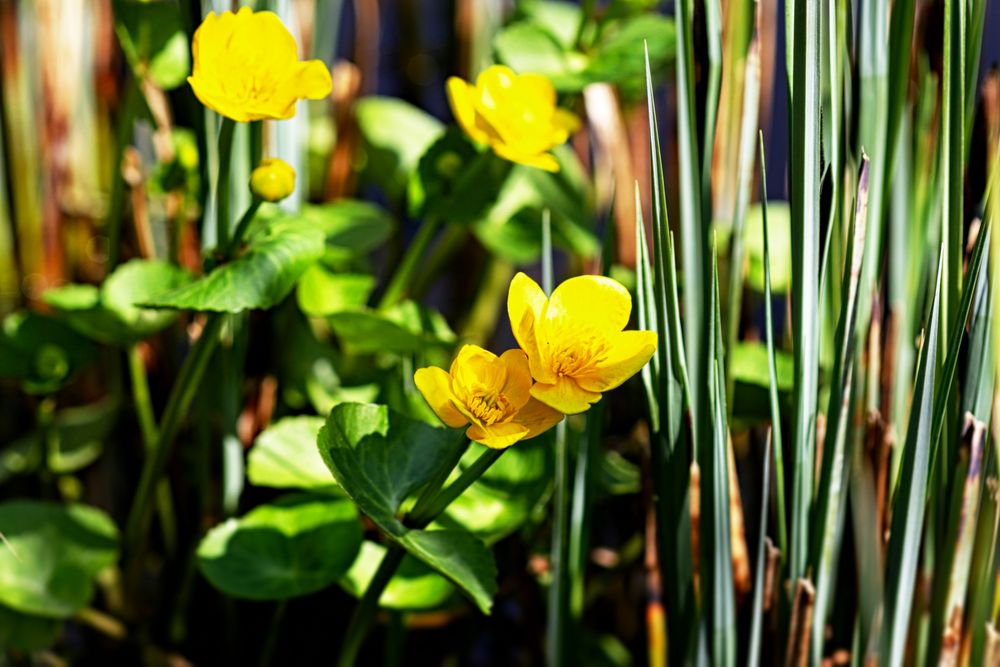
124,313,224,557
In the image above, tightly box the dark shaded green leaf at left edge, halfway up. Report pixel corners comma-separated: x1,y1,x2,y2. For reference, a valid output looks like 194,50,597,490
0,310,97,394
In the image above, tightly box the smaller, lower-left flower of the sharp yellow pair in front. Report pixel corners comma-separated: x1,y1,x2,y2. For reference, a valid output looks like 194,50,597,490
413,345,563,449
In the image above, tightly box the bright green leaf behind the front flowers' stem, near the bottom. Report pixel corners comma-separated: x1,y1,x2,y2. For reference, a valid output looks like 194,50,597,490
339,540,455,611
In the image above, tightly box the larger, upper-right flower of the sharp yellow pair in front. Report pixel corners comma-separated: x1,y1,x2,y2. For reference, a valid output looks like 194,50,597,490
507,273,656,414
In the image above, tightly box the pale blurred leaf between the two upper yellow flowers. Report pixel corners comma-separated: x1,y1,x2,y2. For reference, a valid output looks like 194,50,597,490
355,97,444,197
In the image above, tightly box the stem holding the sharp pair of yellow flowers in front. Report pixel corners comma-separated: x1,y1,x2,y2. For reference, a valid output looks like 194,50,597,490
337,449,507,667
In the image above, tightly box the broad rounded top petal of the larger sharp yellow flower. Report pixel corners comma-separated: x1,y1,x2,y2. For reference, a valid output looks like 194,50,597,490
545,276,632,337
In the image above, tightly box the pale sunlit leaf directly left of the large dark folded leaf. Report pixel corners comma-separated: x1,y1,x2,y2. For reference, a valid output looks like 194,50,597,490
247,416,337,491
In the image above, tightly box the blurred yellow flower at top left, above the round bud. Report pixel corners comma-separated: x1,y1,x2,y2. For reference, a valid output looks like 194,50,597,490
188,7,333,122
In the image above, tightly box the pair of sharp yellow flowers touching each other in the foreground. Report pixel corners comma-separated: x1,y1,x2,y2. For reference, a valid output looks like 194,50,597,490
414,273,656,449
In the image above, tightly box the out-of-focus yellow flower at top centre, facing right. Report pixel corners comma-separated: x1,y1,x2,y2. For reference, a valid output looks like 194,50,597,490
448,65,580,171
